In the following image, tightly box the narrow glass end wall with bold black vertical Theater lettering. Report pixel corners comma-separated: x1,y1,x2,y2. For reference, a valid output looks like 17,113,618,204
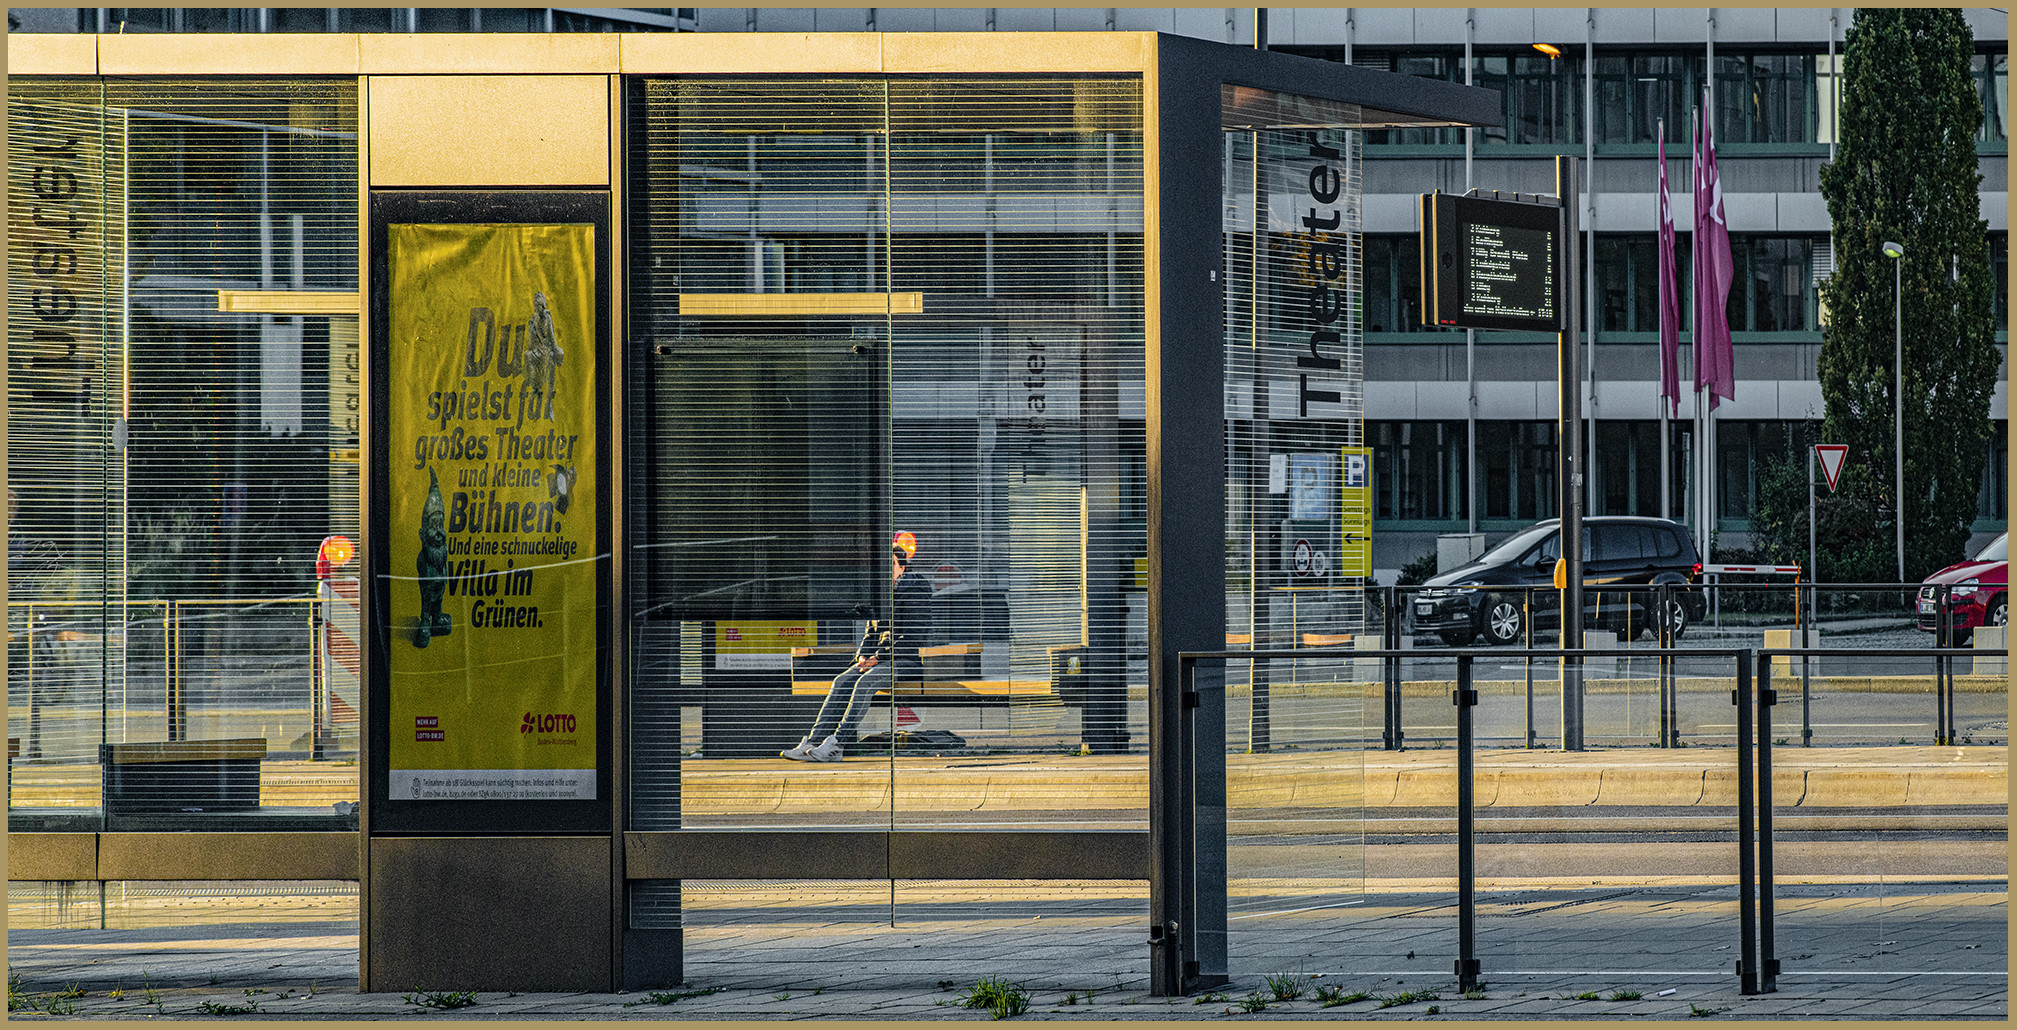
1224,86,1378,976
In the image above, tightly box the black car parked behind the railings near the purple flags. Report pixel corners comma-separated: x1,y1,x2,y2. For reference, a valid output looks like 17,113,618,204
1414,516,1706,647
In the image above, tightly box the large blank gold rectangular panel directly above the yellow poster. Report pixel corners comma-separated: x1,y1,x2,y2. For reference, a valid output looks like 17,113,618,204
367,75,609,189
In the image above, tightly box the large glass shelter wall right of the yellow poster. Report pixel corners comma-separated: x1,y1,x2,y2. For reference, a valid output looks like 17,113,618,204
631,79,1146,846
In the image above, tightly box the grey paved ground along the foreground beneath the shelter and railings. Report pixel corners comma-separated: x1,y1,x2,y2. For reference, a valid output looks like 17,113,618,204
8,877,2009,1022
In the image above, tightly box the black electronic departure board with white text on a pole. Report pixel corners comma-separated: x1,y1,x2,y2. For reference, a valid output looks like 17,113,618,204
1422,194,1565,333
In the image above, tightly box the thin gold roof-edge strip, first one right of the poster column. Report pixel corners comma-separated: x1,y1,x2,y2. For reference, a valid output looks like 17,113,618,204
617,32,879,75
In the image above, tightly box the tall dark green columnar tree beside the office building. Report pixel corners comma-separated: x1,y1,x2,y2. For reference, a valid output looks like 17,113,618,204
1819,8,1999,581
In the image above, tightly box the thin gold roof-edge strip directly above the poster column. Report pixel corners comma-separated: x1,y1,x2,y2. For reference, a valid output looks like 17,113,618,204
357,32,619,75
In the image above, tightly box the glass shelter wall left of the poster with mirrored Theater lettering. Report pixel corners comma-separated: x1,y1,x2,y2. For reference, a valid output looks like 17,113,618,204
8,81,359,828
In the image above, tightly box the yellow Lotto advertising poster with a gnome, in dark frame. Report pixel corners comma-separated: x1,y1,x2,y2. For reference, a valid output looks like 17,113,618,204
385,224,588,800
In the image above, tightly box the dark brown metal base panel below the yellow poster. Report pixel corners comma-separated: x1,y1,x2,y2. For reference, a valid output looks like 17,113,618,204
365,836,617,992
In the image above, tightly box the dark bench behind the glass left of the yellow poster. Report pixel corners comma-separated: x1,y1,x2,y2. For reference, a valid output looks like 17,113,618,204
99,738,266,814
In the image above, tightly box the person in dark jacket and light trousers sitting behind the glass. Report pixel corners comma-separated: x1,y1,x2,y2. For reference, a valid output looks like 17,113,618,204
779,532,932,762
